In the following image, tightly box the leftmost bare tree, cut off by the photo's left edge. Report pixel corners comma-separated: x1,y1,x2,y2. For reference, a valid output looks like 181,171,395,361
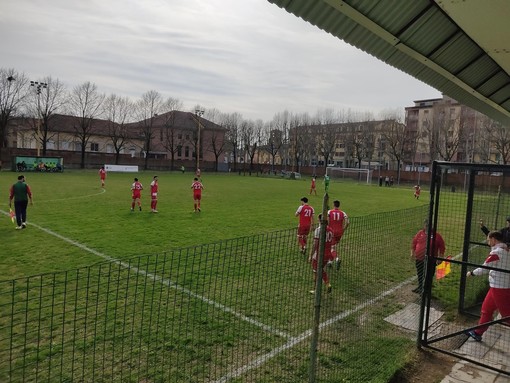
0,69,28,155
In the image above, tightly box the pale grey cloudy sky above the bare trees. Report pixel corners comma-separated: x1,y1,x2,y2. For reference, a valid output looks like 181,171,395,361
0,0,440,121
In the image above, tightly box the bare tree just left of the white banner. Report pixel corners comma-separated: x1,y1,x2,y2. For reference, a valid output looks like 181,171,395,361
69,81,105,169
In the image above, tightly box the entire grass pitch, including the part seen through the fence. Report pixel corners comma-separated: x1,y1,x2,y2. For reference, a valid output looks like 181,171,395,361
0,171,438,382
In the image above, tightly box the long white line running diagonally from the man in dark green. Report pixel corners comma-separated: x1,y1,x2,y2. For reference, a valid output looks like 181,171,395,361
0,210,291,338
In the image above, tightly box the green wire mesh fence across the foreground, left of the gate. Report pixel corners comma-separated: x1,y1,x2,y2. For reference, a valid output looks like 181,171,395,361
0,207,427,382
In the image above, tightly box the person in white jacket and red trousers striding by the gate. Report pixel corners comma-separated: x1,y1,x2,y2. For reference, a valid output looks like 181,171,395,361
466,231,510,342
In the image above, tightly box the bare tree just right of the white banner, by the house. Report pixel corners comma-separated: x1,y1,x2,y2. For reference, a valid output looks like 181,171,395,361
135,90,163,170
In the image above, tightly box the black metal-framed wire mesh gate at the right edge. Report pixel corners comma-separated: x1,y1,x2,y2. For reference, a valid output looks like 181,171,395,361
422,163,510,375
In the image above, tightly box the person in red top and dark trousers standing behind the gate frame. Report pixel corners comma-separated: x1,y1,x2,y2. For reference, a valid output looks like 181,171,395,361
411,220,446,294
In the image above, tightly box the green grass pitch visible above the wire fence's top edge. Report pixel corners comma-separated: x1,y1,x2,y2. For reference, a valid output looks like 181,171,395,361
0,171,427,279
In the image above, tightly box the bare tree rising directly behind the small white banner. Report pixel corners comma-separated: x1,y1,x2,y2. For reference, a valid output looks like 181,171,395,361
104,94,133,164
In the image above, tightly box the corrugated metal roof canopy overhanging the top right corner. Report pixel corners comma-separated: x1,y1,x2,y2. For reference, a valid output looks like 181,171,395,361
268,0,510,126
